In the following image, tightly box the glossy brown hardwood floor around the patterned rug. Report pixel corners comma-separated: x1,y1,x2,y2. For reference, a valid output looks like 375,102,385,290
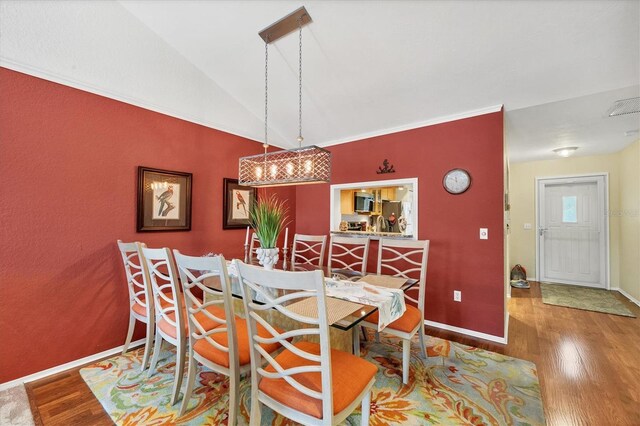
26,283,640,426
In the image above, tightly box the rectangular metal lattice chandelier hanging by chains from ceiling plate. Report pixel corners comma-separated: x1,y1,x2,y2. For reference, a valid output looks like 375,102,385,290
238,6,331,187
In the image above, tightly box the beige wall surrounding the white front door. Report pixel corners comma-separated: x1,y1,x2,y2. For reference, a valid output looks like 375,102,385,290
509,153,616,287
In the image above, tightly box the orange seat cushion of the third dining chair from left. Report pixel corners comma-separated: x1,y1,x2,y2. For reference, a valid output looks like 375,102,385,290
193,317,284,368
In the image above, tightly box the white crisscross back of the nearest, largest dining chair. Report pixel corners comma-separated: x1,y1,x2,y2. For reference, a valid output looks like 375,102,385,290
238,262,333,419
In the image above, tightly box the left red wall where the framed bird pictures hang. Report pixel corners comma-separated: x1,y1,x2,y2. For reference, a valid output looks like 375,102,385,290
0,68,295,383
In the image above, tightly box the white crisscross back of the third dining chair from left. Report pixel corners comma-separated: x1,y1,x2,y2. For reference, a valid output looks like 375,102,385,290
173,250,239,375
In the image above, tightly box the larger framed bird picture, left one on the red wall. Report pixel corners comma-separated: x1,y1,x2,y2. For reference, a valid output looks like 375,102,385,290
137,166,191,232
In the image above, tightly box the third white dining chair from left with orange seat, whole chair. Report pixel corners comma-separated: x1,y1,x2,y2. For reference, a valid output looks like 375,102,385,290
173,250,283,425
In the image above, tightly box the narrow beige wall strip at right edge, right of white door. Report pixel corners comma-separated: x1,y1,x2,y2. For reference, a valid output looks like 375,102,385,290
615,141,640,300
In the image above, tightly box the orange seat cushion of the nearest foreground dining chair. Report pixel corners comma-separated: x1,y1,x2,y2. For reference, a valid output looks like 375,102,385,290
258,342,378,419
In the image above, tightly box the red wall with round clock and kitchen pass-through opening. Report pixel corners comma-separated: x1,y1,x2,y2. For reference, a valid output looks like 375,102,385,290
296,112,504,336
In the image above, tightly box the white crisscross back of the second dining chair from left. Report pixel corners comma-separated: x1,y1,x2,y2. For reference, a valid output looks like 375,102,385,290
142,247,186,345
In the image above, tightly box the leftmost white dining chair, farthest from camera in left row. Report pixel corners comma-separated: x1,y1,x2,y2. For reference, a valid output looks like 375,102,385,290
118,240,155,371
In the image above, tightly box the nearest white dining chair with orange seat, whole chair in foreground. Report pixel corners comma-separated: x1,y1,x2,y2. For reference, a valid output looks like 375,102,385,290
238,262,377,425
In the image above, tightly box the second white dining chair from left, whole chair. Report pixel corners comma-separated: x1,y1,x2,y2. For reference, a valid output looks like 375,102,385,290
142,247,187,405
